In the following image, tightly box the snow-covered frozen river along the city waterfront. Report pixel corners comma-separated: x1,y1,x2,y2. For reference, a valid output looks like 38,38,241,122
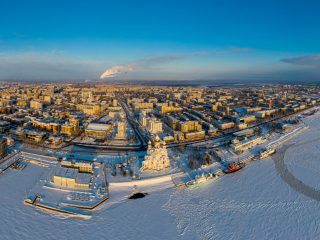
0,113,320,239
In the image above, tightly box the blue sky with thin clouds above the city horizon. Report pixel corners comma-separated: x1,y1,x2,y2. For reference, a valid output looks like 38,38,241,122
0,0,320,81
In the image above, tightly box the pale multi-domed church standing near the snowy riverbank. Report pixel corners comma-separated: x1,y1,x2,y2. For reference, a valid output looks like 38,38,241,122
141,136,170,171
